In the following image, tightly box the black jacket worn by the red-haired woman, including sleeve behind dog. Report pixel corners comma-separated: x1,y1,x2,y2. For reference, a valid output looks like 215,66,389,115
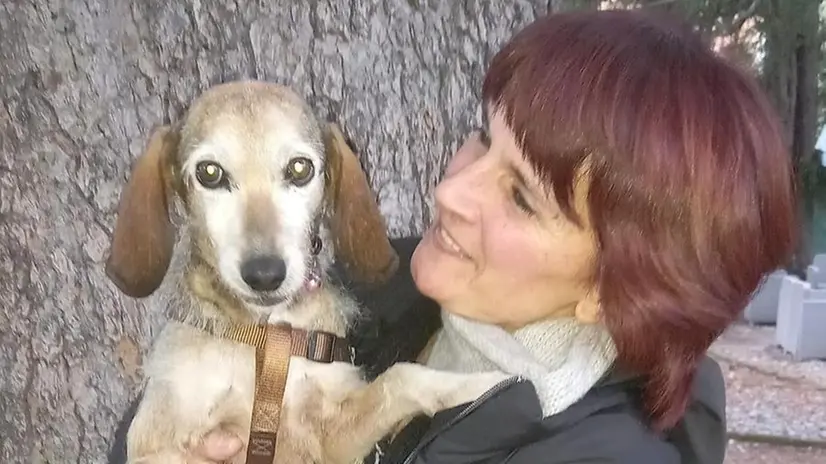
110,238,726,464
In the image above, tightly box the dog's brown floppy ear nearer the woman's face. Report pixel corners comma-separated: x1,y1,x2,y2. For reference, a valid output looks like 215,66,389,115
324,123,399,284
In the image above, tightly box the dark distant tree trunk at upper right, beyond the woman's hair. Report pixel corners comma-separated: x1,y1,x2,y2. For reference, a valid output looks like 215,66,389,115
761,0,820,274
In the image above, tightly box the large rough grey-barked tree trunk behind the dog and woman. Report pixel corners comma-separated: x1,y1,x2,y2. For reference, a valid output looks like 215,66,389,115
0,0,549,464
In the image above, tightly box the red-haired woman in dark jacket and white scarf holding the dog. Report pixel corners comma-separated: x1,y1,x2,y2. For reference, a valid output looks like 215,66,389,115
187,7,796,464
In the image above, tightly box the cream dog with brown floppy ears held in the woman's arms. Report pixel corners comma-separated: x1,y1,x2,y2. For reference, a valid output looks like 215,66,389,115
106,80,508,464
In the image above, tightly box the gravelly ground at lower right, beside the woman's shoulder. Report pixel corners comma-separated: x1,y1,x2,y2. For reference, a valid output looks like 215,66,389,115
710,324,826,464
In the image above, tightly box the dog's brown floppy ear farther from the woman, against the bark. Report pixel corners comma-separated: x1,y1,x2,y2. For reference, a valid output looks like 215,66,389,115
106,126,178,298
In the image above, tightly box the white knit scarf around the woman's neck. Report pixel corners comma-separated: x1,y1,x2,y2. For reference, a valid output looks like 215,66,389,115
427,311,616,417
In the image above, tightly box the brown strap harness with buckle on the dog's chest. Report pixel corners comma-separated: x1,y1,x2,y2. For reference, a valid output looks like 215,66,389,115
206,324,352,464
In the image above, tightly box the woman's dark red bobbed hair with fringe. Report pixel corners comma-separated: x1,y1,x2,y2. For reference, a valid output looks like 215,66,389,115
483,10,797,430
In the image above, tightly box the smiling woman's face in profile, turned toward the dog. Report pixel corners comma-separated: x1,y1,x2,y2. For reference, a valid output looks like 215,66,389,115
411,109,598,330
